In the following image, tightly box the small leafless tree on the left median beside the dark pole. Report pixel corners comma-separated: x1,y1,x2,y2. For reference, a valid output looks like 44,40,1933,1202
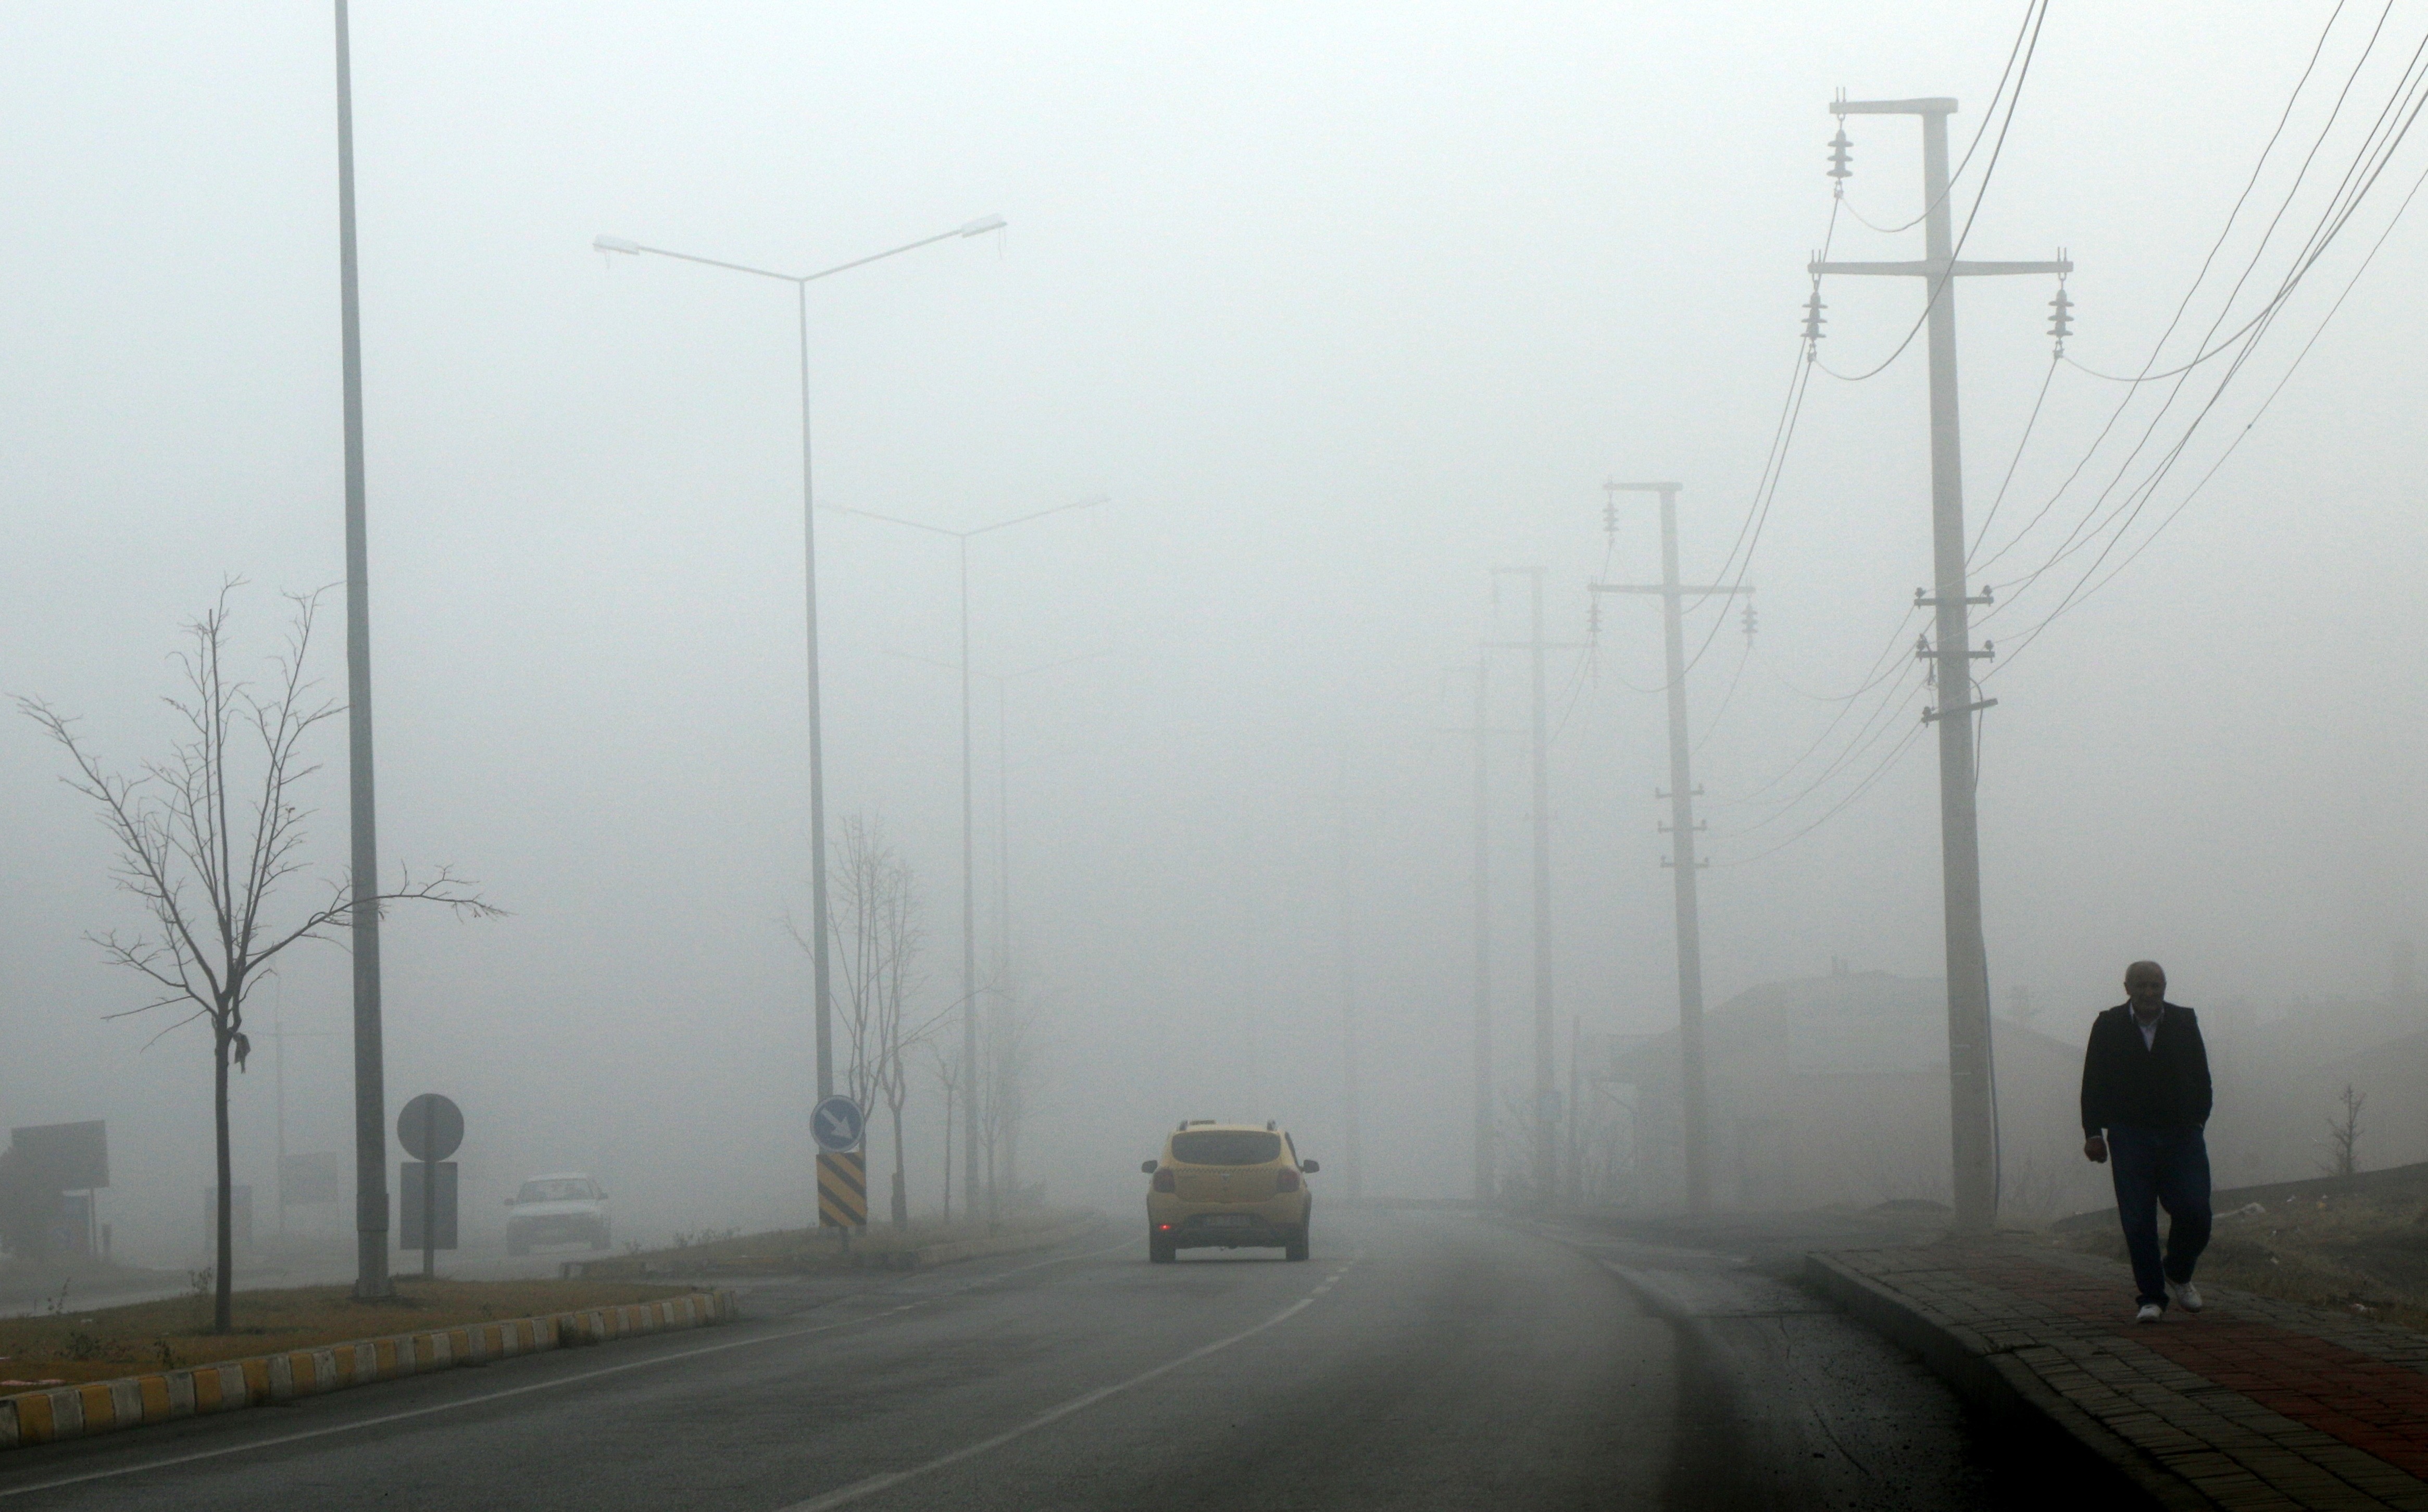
17,578,503,1332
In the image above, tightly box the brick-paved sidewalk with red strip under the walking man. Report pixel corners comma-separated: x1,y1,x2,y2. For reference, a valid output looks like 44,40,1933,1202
1809,1240,2428,1512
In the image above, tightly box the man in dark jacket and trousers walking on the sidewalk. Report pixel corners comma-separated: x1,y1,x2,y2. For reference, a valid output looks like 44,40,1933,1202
2083,961,2209,1323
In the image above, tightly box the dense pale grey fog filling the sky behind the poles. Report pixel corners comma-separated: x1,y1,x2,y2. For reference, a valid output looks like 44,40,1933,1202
0,0,2428,1267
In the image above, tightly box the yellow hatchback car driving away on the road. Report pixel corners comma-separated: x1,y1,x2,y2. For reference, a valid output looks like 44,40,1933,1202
1138,1119,1318,1265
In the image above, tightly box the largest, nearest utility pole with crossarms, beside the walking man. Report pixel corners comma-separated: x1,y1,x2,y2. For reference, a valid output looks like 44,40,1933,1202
1807,97,2073,1233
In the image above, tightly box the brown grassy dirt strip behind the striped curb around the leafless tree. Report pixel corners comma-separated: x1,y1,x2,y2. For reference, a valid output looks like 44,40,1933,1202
0,1279,685,1393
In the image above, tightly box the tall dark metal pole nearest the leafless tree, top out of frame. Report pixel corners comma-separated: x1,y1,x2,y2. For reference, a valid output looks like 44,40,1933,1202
337,0,396,1301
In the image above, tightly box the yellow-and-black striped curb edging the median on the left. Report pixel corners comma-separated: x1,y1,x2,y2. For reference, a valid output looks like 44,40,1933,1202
0,1291,733,1452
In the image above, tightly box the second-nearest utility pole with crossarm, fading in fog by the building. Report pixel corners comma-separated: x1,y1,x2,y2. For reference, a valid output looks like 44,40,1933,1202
1593,483,1753,1214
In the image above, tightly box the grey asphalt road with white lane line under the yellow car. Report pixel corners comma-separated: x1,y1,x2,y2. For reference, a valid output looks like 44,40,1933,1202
0,1211,2064,1512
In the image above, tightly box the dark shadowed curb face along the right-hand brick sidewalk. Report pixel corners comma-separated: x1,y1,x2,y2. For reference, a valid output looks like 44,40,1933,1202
1804,1252,2217,1512
